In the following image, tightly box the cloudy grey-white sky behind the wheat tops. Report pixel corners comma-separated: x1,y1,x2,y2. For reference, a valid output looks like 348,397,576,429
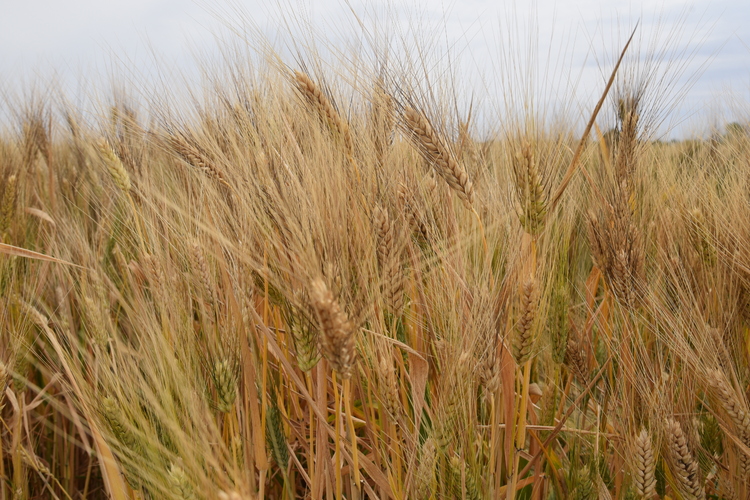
0,0,750,137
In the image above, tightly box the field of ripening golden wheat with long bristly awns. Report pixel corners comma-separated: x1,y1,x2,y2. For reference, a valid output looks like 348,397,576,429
0,11,750,500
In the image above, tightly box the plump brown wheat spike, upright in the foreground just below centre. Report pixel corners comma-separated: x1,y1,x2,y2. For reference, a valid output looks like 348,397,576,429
310,278,357,379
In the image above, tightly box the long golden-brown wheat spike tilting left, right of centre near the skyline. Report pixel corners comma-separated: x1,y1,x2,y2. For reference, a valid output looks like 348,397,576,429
404,107,474,205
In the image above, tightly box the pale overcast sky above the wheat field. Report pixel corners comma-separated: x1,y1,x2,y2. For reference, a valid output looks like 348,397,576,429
0,0,750,135
